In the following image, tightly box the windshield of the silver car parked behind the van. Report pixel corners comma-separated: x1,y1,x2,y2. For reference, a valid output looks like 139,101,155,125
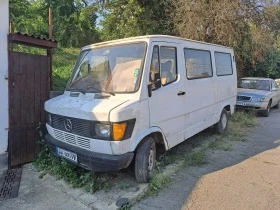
238,79,270,91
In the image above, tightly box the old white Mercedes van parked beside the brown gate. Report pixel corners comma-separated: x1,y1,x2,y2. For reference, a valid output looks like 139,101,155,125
45,35,237,182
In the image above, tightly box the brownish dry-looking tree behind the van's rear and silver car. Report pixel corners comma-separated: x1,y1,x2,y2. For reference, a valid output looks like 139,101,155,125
171,0,279,76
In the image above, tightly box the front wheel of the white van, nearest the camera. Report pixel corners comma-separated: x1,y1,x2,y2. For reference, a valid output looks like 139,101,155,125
134,137,156,183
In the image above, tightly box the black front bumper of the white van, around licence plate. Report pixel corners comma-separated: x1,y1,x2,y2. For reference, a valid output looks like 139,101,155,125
45,134,134,172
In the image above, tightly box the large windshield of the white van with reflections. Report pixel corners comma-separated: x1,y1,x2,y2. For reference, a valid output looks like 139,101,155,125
66,42,146,93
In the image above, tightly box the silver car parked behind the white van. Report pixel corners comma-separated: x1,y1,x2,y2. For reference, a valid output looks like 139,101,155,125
236,77,280,117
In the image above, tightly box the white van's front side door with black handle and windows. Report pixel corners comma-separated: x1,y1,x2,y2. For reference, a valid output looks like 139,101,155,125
149,42,185,148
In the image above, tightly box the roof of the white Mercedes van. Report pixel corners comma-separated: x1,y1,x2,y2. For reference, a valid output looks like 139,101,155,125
82,35,231,50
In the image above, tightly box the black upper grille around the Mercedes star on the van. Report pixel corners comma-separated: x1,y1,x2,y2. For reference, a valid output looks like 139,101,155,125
51,114,93,138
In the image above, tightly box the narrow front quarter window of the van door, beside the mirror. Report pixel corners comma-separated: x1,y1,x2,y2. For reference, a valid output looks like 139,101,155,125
150,45,161,90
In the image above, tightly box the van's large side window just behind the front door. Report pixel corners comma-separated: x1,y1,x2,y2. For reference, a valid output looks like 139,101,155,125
184,49,213,79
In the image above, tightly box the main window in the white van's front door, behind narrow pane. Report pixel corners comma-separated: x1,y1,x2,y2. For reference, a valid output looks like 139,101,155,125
160,47,177,86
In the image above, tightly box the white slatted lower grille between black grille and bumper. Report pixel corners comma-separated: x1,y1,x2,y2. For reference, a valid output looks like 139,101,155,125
53,129,90,149
